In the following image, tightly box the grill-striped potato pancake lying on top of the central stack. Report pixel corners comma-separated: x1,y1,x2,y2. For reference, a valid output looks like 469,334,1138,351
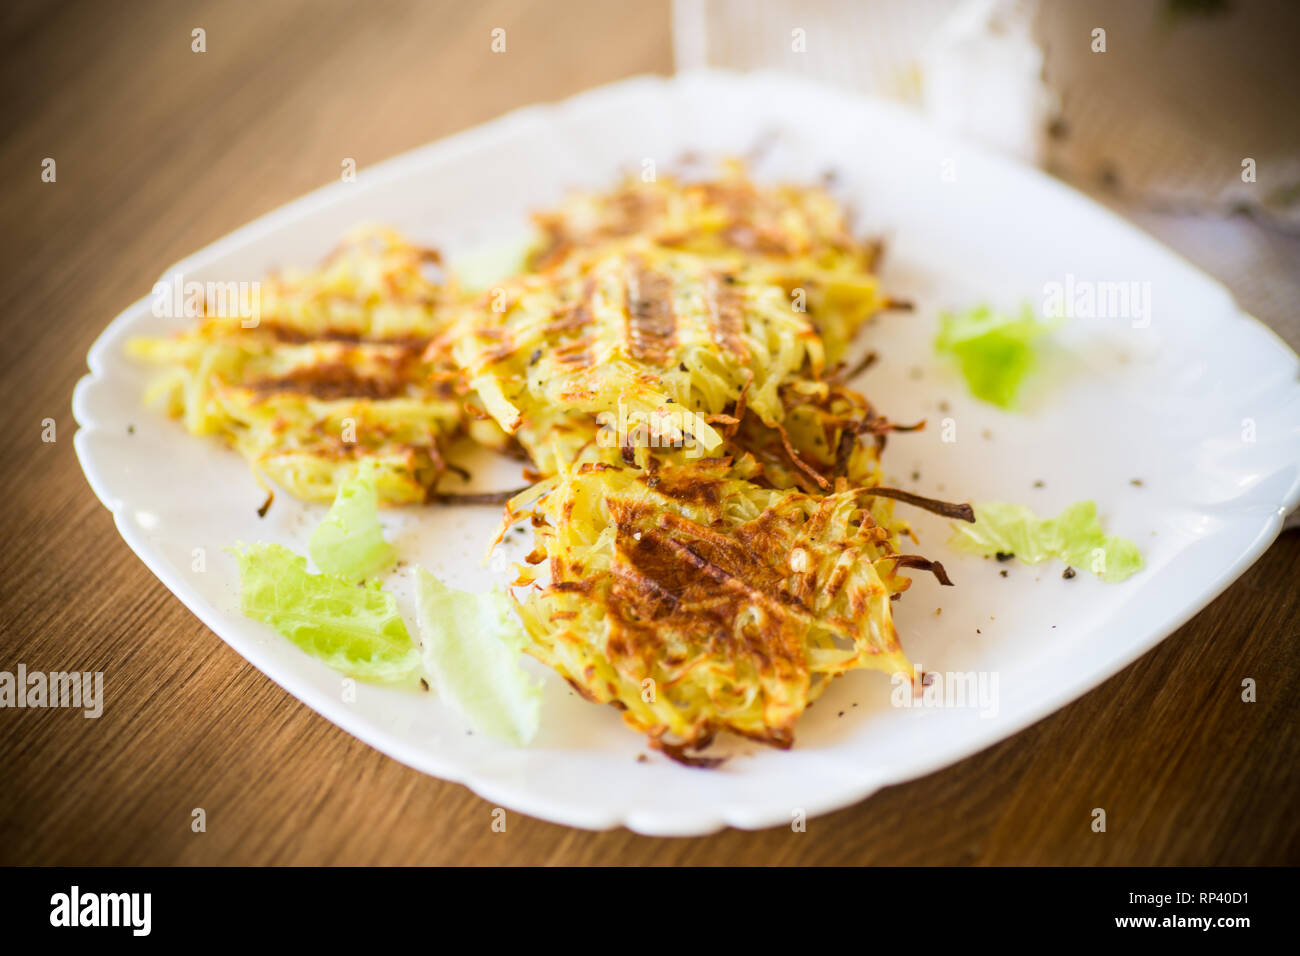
452,241,823,473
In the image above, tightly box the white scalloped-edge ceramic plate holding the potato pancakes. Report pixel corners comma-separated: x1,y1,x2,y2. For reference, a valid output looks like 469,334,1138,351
73,73,1300,835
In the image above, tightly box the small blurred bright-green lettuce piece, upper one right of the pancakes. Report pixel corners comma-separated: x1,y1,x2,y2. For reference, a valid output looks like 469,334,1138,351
935,304,1053,408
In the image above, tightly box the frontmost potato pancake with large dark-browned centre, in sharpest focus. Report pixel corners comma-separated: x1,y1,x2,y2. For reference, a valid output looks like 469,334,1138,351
511,459,911,762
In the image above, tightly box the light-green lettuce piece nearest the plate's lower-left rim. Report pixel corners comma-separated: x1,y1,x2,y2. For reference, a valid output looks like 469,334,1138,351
231,544,420,683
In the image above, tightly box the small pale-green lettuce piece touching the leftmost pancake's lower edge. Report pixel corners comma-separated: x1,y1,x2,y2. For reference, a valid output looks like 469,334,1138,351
307,462,397,581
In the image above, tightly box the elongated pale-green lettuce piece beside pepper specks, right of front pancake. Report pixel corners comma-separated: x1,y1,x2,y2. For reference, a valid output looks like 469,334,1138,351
948,501,1143,583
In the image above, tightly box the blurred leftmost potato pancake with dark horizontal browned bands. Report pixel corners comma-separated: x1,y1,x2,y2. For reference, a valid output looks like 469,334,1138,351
130,229,463,505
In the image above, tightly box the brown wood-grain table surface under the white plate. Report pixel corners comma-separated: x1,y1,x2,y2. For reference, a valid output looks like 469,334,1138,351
0,0,1300,864
